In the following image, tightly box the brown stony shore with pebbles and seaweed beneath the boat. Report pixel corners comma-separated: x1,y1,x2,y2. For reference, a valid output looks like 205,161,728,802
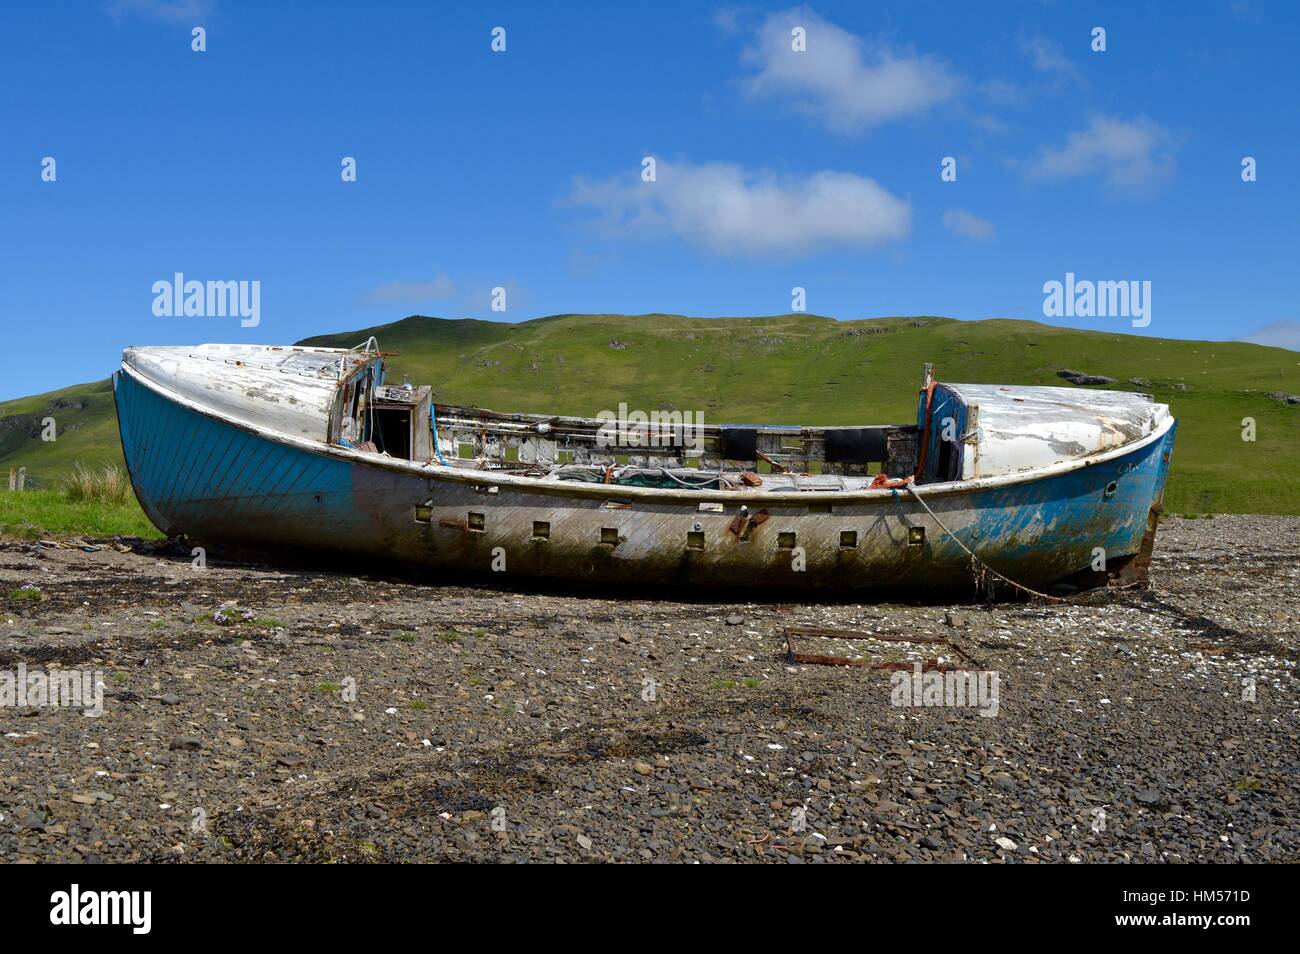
0,517,1300,863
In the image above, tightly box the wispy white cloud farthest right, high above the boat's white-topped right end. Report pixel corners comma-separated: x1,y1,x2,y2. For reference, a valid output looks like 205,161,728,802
1024,116,1174,186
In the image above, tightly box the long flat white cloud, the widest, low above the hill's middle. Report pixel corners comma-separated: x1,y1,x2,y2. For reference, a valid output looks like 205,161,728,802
569,160,911,255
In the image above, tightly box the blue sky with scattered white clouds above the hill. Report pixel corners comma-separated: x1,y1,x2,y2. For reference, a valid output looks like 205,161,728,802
0,0,1300,398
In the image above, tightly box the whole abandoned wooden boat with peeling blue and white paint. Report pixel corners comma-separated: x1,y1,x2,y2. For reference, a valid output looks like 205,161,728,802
114,339,1177,595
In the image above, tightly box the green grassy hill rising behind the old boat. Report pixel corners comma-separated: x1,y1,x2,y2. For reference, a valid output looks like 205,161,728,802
0,315,1300,513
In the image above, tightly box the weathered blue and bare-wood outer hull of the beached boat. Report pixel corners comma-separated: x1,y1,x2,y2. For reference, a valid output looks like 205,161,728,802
114,372,1175,595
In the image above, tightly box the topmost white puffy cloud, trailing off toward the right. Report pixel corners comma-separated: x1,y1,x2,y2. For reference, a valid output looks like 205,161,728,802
744,6,963,133
